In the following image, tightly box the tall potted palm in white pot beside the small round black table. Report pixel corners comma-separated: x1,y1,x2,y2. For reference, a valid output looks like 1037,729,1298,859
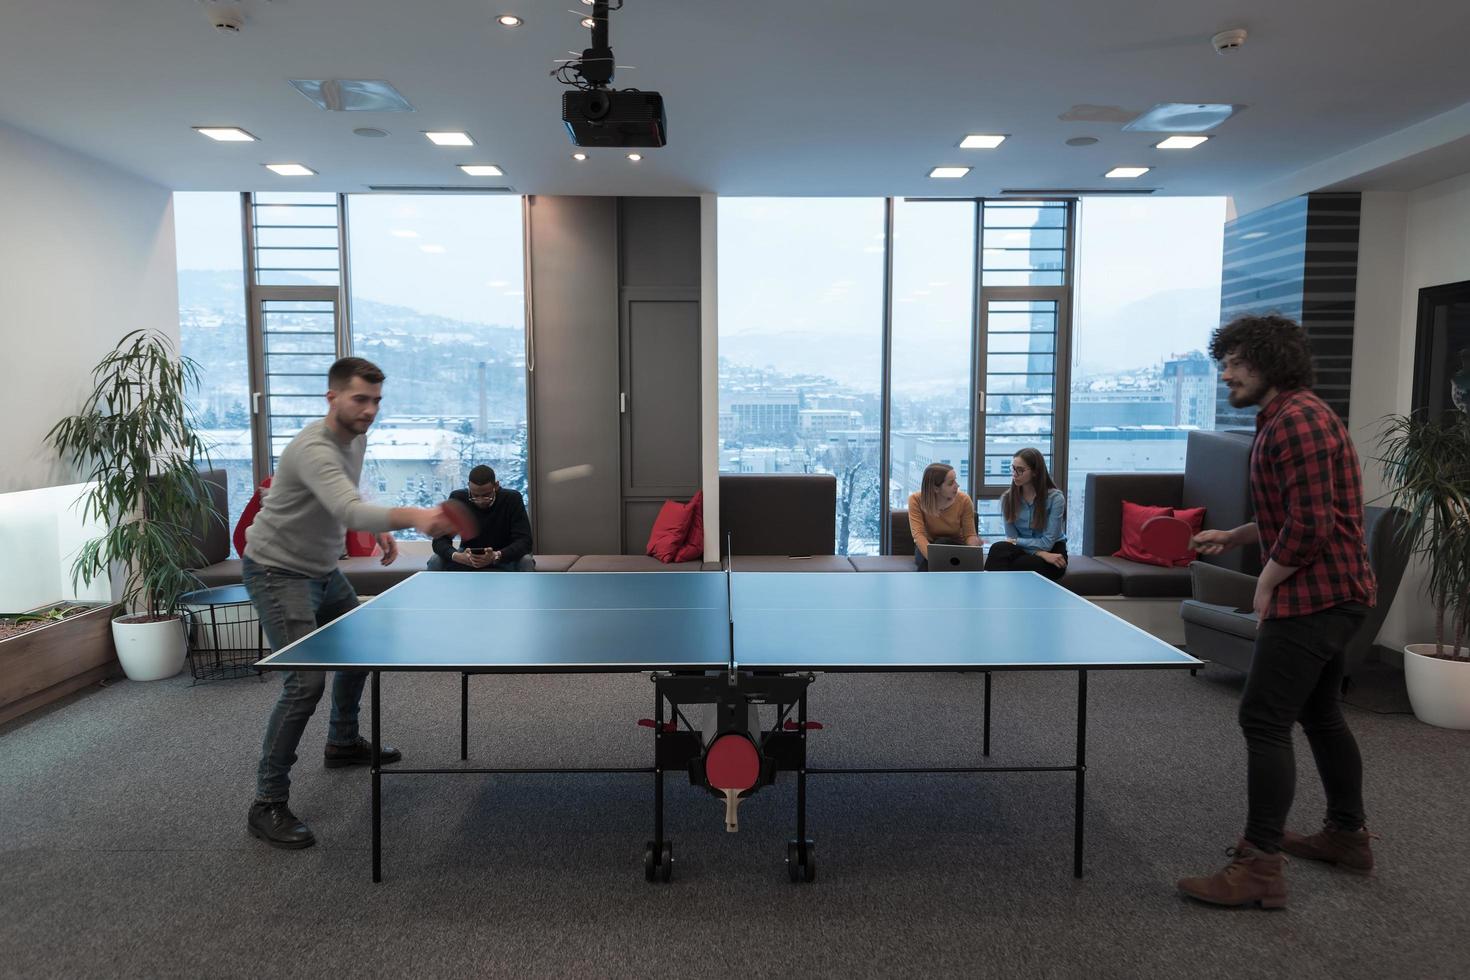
47,331,219,680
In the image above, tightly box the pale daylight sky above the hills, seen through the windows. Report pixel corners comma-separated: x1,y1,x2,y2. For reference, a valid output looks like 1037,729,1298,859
175,194,1225,388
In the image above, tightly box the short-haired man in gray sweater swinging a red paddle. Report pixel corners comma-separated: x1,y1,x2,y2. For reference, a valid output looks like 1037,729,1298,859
243,357,451,848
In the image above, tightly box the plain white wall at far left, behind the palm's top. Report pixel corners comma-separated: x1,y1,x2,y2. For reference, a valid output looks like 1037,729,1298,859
0,123,178,492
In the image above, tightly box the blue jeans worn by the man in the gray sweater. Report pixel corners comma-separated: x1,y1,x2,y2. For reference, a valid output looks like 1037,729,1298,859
243,558,368,802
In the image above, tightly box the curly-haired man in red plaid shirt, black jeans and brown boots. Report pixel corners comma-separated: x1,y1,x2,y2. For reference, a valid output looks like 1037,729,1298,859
1179,316,1377,908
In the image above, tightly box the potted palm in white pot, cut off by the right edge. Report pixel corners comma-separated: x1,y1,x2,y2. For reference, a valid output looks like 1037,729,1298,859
1379,411,1470,729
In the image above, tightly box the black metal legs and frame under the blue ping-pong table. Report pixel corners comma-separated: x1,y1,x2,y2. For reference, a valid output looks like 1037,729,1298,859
358,664,1189,883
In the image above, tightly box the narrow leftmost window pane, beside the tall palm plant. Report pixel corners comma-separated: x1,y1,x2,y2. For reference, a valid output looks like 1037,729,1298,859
173,192,254,537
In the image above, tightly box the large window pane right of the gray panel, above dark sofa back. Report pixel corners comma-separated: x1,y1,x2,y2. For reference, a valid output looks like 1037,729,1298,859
719,198,885,554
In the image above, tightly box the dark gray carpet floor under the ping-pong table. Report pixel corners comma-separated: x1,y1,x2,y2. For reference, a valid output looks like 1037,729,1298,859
0,658,1470,979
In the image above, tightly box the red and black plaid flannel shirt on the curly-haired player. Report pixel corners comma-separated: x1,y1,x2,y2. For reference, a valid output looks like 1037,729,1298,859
1251,389,1377,619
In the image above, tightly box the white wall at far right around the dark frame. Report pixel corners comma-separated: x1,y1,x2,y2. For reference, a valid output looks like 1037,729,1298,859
1349,173,1470,649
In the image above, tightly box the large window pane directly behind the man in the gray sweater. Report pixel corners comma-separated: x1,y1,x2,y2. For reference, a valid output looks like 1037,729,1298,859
348,195,529,536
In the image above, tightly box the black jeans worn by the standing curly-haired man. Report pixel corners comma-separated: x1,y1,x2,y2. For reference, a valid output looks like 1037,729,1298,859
1241,604,1367,854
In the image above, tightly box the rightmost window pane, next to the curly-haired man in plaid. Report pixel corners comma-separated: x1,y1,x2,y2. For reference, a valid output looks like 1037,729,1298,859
1066,197,1225,540
